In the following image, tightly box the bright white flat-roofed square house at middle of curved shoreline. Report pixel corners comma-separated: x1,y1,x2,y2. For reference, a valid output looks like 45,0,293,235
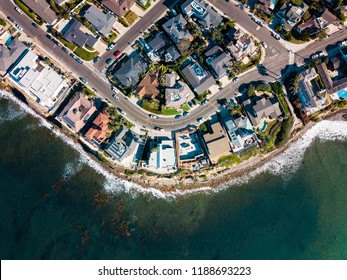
147,139,177,171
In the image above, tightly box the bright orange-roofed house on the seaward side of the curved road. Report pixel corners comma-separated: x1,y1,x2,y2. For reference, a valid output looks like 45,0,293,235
85,110,112,145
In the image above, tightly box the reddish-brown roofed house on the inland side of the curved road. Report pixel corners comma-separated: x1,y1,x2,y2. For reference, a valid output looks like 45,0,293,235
136,72,160,100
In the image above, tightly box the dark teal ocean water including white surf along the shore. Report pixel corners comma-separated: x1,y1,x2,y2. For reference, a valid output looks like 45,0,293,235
0,95,347,259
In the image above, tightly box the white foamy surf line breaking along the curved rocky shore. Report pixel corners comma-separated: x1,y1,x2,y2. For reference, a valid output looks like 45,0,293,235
0,91,347,199
